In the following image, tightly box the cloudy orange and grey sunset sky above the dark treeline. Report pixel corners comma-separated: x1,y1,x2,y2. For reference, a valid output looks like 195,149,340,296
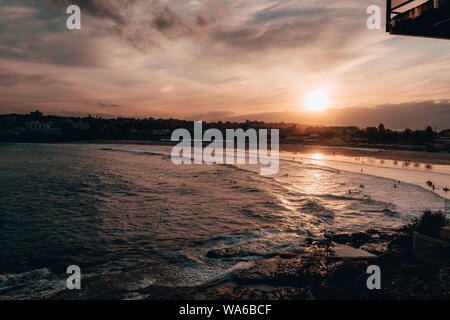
0,0,450,129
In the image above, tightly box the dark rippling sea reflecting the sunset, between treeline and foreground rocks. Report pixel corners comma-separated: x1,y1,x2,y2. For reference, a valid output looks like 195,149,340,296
0,144,450,299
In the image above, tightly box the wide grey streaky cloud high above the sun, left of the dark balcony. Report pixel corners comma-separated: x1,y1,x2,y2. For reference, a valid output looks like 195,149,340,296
212,5,367,54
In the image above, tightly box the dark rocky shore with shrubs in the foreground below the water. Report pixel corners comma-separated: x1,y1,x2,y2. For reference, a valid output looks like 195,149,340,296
51,213,450,300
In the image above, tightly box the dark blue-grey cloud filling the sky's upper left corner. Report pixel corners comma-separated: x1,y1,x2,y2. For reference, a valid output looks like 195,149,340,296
0,1,104,67
